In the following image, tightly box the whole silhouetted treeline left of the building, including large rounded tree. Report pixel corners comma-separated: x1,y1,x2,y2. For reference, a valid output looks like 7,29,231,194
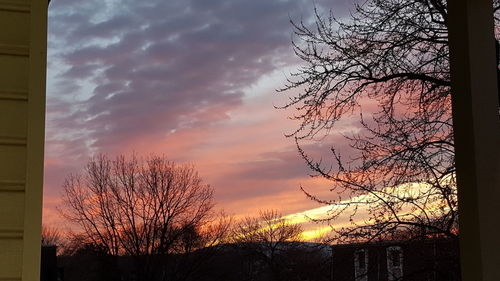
51,154,325,281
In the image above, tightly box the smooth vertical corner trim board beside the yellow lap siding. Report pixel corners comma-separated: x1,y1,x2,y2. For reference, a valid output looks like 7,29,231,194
22,0,48,281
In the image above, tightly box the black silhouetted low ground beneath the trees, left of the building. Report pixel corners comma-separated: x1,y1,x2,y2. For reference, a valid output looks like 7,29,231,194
58,238,330,281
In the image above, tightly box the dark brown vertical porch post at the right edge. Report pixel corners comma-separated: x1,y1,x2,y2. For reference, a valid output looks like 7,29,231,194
448,0,500,281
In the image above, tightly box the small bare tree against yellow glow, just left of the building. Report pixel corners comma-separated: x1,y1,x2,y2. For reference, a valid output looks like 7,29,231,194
231,210,302,281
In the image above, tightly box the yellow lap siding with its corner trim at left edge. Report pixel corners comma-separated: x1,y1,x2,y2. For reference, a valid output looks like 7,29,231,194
0,0,47,281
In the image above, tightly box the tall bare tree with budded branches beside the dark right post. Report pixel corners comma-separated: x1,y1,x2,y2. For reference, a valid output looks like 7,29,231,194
278,0,500,240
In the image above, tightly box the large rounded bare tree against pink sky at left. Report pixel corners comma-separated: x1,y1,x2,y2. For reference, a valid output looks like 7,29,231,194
61,155,227,280
